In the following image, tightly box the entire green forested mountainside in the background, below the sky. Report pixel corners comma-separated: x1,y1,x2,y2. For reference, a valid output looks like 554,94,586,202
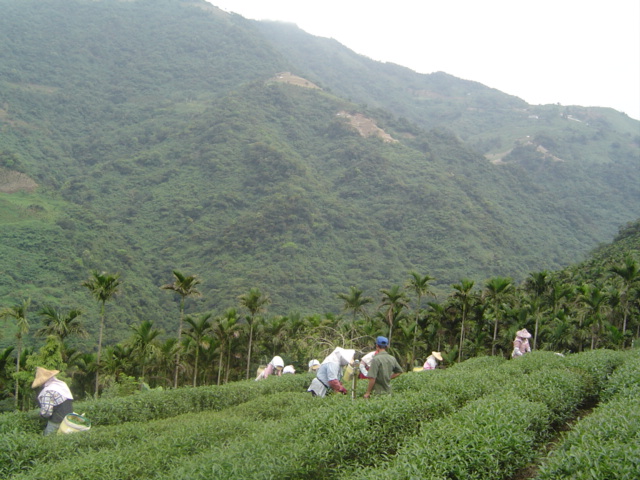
0,0,640,342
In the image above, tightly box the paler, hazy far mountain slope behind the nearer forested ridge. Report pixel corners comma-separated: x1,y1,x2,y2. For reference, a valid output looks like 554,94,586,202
255,16,640,253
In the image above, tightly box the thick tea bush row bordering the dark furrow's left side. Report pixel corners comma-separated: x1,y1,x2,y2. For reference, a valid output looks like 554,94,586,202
344,353,592,479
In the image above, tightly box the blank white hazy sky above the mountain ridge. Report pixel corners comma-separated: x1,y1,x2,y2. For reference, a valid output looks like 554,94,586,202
209,0,640,119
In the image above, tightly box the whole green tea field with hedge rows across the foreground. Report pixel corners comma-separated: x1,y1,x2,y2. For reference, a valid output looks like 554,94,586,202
0,349,640,480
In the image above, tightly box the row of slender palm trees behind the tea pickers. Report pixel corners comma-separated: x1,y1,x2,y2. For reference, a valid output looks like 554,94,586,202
0,256,640,407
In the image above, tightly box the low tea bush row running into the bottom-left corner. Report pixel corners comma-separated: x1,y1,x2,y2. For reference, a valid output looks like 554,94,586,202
0,393,324,479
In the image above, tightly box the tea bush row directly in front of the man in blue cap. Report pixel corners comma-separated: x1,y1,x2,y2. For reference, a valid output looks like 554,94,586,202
152,386,452,479
